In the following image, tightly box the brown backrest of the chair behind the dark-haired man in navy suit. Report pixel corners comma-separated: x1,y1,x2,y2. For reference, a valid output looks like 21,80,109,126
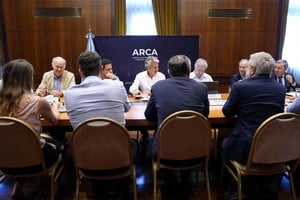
157,110,211,168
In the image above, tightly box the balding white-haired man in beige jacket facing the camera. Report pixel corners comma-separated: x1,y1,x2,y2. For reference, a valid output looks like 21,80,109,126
36,57,75,97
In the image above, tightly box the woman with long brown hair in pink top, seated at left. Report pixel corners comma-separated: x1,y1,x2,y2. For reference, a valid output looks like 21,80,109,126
0,59,60,199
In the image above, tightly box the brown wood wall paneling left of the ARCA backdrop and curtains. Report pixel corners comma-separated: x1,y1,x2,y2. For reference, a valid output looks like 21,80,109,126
3,0,111,87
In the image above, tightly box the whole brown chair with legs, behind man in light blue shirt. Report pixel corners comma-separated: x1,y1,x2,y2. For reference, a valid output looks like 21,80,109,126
72,117,137,200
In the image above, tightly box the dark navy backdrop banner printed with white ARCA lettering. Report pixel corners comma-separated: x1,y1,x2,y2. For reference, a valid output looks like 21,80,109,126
93,35,200,91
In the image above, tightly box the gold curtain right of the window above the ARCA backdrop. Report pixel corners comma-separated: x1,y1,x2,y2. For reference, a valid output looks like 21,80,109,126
152,0,177,35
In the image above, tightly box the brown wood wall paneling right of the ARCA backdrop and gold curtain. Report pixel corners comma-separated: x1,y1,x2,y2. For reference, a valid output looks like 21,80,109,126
180,0,280,91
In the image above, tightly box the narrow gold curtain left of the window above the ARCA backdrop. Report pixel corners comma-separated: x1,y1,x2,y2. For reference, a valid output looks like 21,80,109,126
115,0,126,35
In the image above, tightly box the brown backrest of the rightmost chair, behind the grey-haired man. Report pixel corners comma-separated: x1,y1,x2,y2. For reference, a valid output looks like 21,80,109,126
247,113,300,167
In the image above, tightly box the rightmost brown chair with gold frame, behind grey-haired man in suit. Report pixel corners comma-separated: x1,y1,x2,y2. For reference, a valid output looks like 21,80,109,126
225,113,300,200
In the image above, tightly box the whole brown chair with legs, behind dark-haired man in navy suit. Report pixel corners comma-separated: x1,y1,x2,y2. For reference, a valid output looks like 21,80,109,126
152,110,211,200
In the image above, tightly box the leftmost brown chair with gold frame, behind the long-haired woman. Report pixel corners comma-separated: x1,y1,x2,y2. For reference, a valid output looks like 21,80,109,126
0,117,63,200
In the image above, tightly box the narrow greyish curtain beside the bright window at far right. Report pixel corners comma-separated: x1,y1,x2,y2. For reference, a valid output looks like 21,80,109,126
276,0,289,59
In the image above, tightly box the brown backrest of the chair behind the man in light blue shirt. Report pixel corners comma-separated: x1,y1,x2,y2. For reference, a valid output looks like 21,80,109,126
72,117,132,170
